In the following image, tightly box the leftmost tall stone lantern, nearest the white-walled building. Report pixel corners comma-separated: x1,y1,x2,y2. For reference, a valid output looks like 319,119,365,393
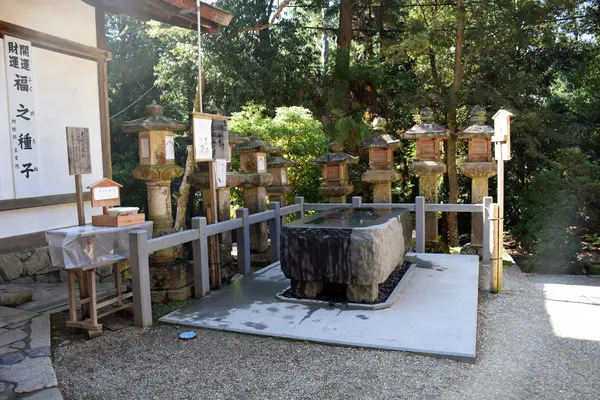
122,102,189,265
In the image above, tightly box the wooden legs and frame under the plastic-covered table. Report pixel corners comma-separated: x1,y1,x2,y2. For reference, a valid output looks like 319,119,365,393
66,258,133,336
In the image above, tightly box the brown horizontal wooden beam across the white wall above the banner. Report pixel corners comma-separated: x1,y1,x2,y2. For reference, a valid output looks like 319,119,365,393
0,21,112,61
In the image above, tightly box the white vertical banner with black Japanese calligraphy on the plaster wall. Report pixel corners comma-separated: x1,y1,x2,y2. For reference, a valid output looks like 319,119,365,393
4,36,40,198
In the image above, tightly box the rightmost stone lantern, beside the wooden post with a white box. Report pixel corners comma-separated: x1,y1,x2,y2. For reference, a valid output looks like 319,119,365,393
458,106,496,254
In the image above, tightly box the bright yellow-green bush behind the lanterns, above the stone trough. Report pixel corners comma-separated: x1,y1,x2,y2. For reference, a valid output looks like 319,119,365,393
230,103,328,202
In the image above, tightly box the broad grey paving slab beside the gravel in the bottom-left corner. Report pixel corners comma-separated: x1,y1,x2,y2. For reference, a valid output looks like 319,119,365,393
0,357,57,393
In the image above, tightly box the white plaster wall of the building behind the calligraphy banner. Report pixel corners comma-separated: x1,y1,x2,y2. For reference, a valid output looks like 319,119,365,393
0,0,103,238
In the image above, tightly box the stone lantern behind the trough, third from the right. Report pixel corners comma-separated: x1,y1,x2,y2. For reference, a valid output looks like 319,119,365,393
361,118,402,203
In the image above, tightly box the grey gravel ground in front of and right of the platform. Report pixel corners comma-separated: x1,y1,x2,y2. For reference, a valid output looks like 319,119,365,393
54,267,600,400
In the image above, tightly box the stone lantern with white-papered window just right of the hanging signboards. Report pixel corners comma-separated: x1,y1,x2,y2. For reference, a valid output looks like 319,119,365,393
232,135,280,253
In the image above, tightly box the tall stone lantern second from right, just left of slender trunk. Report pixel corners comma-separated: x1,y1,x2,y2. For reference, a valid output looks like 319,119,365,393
402,107,450,248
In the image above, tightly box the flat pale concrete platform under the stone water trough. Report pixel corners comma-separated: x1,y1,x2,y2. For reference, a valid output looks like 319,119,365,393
161,253,479,360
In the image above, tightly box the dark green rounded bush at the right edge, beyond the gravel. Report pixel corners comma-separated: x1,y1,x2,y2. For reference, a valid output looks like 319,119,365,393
513,148,600,272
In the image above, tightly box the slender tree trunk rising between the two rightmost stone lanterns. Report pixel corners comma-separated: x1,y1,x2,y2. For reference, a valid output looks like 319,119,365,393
445,0,465,246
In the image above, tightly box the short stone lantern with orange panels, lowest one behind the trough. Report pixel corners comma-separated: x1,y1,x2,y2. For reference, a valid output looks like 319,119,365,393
313,142,358,203
